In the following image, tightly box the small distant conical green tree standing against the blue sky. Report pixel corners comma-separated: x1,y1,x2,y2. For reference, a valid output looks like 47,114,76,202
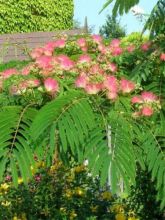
99,15,125,39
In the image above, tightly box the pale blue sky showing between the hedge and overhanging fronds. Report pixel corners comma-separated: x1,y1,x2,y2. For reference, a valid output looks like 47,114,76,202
74,0,157,33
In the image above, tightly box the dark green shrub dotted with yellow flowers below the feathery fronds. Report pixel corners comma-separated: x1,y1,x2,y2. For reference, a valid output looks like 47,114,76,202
0,161,139,220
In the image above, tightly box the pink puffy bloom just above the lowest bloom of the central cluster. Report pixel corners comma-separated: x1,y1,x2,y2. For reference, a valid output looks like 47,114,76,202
103,76,118,93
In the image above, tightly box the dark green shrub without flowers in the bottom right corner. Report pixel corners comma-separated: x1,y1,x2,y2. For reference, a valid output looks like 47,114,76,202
123,167,164,220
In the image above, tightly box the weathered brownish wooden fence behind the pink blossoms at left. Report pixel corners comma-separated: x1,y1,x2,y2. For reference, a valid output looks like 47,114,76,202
0,26,88,62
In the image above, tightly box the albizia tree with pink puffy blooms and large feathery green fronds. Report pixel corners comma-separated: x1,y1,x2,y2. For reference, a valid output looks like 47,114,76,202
0,35,165,207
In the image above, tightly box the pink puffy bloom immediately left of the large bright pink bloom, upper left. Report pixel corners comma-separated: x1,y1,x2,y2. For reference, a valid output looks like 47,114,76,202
36,55,53,69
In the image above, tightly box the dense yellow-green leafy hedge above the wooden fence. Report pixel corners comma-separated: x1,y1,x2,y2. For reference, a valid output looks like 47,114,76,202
0,0,73,34
